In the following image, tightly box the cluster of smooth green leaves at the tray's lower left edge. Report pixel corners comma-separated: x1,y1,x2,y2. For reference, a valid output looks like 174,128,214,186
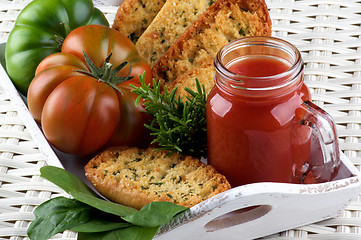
27,166,188,240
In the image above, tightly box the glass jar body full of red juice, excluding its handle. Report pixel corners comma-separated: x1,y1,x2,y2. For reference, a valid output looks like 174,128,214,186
207,37,337,187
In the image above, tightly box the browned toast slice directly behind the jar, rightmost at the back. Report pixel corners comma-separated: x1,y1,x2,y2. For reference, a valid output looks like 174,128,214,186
152,0,272,93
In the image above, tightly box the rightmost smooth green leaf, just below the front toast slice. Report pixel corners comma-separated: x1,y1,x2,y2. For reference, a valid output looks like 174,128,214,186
123,202,188,227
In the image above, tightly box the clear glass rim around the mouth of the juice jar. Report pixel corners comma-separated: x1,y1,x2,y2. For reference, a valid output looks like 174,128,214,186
214,36,304,90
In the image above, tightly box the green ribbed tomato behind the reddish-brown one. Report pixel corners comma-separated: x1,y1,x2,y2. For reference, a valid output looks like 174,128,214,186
5,0,109,95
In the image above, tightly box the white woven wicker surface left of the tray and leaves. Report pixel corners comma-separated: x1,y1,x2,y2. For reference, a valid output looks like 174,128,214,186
0,87,72,240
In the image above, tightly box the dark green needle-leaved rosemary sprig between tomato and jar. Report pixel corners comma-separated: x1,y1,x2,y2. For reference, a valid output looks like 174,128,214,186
132,75,208,157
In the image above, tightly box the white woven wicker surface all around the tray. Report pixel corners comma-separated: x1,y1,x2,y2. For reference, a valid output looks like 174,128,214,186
0,0,361,240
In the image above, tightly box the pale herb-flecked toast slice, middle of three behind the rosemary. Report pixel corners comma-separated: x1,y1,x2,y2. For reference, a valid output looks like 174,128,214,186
135,0,213,66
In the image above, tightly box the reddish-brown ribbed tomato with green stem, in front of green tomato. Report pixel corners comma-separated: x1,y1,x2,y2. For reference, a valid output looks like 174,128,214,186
28,25,152,155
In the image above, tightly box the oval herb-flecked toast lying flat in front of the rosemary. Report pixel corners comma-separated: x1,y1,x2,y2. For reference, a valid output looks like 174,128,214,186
85,147,231,209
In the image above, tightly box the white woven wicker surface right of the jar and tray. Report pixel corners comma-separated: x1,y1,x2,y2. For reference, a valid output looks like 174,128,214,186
264,0,361,240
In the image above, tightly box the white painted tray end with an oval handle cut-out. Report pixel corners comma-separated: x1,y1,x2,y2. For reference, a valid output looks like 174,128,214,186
156,154,361,240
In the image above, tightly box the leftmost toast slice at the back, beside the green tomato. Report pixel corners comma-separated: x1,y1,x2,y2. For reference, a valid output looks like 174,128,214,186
113,0,166,43
